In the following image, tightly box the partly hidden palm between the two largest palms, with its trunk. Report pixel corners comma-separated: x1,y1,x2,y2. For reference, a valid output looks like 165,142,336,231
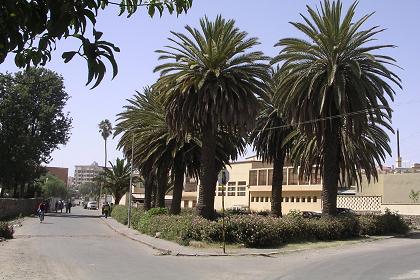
250,69,290,217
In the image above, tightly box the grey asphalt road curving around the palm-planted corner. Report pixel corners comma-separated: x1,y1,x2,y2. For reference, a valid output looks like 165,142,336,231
0,207,420,280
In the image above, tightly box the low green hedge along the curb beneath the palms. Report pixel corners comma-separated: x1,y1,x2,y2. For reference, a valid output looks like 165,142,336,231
112,206,409,247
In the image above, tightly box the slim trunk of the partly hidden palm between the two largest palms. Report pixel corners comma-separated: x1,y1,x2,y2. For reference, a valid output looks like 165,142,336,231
271,152,286,217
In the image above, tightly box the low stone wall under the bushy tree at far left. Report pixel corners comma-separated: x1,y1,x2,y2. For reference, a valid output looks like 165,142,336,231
0,198,42,220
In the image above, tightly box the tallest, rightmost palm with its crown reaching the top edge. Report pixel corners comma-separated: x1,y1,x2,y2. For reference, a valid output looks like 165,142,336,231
272,0,401,215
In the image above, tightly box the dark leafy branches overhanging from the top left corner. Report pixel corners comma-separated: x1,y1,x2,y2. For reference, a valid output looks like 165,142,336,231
0,0,192,87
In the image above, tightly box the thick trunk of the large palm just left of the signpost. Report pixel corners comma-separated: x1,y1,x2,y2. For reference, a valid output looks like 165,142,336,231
197,129,217,219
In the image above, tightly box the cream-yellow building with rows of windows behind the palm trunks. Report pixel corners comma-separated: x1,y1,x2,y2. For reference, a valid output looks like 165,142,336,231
182,157,322,214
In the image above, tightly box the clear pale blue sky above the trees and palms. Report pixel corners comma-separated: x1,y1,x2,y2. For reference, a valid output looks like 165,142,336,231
0,0,420,175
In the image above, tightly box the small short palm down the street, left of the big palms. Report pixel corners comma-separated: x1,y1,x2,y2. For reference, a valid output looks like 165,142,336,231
101,158,131,204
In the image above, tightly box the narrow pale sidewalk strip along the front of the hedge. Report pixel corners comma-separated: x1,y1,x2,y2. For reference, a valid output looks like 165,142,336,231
101,215,288,257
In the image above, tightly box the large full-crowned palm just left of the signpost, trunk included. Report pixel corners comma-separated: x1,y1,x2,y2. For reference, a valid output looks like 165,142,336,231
155,16,268,219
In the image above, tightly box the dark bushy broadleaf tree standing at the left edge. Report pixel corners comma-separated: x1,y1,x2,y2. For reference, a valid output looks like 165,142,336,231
0,68,72,197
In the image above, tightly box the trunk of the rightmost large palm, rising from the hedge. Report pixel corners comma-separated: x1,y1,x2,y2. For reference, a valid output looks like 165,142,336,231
322,119,340,216
